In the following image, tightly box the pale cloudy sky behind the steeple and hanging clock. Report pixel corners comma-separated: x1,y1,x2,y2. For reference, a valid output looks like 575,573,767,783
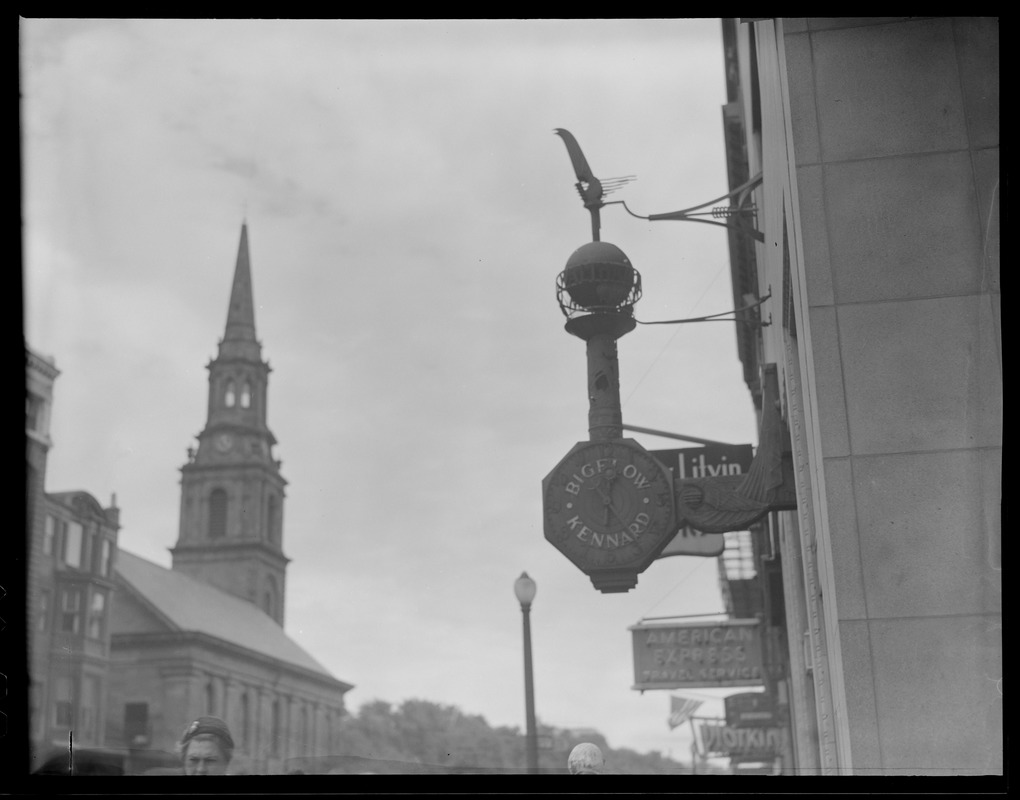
20,18,757,760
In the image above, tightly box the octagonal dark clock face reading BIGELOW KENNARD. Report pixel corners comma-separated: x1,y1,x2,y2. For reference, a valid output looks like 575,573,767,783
542,439,678,592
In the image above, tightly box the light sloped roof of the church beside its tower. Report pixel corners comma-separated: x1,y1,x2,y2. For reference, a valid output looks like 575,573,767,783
116,550,343,683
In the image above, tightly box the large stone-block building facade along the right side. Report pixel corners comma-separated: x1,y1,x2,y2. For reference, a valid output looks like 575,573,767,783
724,17,1004,774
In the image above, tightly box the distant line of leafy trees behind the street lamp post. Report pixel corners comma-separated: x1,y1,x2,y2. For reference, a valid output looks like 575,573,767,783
286,700,691,774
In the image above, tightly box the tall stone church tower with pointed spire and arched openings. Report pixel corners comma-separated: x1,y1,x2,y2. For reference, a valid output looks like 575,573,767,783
170,222,290,626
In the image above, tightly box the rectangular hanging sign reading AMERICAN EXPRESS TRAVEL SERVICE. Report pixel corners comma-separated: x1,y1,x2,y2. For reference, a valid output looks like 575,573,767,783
628,619,765,692
